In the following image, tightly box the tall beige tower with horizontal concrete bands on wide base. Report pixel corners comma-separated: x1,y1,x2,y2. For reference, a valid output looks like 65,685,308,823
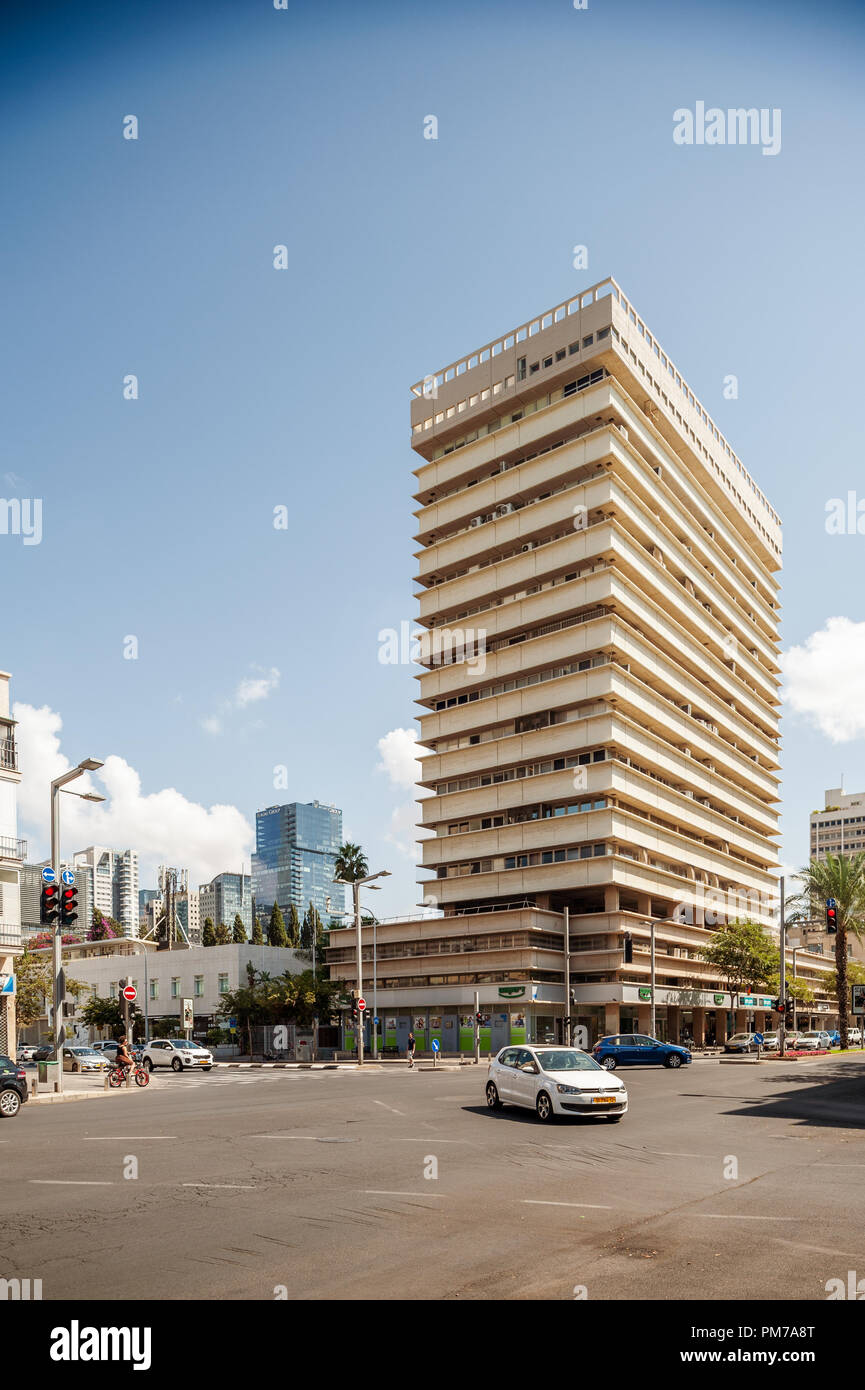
330,279,826,1048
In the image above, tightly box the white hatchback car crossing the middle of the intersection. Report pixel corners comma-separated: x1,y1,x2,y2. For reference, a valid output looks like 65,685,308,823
487,1045,627,1120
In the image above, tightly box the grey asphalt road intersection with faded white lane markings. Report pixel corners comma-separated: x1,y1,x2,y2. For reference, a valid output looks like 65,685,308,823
0,1056,865,1301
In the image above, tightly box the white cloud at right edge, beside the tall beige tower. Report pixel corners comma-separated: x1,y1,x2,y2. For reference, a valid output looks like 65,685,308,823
780,617,865,744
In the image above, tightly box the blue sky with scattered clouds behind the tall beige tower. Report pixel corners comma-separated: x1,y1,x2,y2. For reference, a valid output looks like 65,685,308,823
0,0,865,915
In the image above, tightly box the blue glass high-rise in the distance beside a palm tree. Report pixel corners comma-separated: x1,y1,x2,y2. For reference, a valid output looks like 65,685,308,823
250,801,345,924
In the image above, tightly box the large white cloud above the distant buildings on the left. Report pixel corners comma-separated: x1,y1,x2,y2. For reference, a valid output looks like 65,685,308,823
14,703,253,887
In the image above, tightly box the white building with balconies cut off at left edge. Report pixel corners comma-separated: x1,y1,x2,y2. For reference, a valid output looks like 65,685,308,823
0,671,26,1056
